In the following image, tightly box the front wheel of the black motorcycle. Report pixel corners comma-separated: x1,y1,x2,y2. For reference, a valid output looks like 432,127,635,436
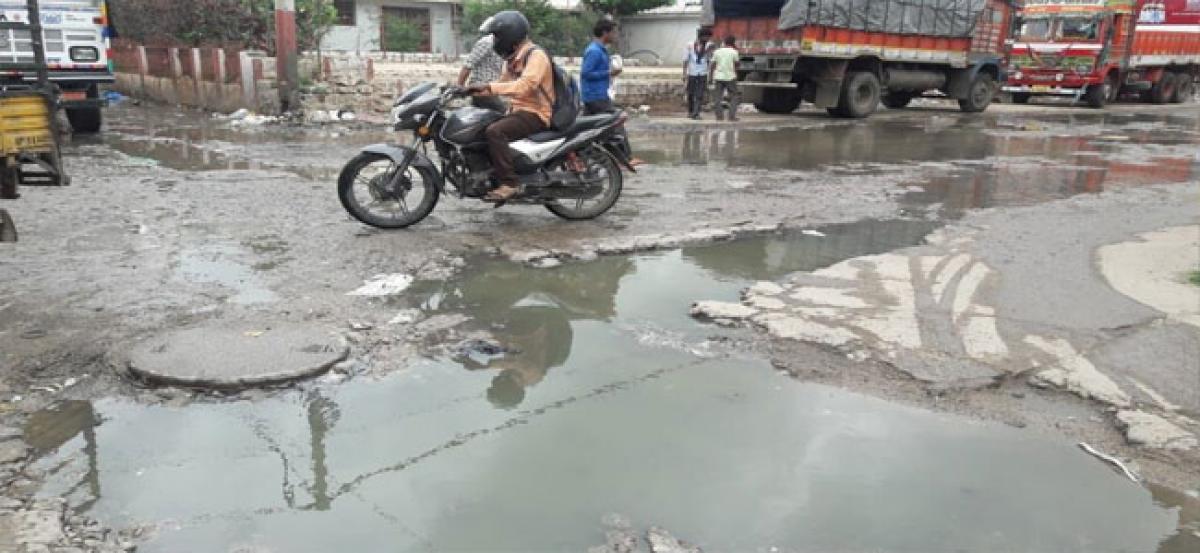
337,154,438,228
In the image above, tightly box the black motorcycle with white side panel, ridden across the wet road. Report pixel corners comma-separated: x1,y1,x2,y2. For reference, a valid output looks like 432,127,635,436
337,83,634,228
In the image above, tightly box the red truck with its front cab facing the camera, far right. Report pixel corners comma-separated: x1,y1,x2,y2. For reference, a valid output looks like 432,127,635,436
1003,0,1200,108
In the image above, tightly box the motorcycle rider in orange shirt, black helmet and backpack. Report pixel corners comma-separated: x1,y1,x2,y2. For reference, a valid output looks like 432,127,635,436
468,10,554,202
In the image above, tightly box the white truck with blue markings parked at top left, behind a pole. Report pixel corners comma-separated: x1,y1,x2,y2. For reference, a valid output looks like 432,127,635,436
0,0,114,133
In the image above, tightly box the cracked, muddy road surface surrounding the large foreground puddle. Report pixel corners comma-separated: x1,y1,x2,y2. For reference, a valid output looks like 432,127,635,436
0,101,1200,551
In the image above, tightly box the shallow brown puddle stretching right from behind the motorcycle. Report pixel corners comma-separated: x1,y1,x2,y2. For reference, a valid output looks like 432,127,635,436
632,113,1200,212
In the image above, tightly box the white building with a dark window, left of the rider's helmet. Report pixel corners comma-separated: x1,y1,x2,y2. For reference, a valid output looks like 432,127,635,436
320,0,462,56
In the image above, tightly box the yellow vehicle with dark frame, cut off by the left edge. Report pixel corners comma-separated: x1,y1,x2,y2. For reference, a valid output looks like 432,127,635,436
0,0,68,241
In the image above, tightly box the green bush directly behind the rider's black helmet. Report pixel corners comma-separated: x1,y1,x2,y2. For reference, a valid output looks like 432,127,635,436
462,0,599,56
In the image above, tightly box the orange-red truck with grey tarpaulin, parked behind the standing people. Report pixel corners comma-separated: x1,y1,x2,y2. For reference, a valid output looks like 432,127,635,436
702,0,1018,118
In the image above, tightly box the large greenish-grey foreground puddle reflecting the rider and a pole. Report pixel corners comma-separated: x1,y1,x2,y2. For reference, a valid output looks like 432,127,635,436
28,222,1189,552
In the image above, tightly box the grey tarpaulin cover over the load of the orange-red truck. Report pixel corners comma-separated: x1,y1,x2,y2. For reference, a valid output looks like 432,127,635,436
704,0,986,37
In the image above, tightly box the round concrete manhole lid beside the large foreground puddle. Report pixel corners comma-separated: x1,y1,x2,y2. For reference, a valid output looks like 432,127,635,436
128,323,349,387
